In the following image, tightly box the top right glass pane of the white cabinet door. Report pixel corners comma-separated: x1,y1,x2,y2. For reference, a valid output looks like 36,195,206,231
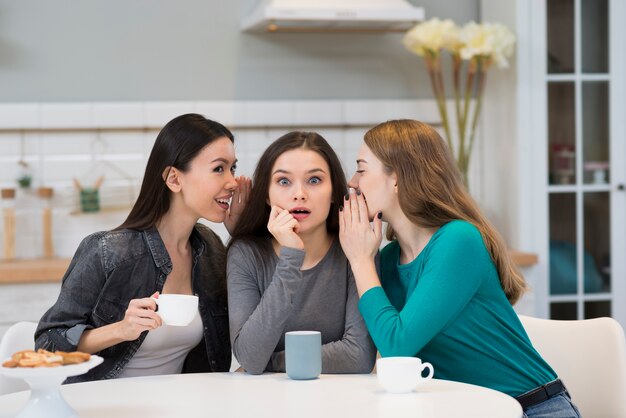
580,0,609,73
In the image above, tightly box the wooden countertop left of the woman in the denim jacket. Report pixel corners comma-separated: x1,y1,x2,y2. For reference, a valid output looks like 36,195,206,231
0,258,70,283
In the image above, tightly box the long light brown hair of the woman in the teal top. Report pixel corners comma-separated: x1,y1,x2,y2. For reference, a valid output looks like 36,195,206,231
365,120,527,304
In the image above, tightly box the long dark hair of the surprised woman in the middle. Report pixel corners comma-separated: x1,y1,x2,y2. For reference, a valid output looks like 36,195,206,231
229,131,348,246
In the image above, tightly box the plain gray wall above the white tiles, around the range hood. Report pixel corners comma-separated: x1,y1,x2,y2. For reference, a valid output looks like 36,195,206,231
0,0,479,102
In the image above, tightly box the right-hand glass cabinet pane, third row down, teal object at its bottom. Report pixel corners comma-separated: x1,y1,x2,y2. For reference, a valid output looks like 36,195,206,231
583,192,611,293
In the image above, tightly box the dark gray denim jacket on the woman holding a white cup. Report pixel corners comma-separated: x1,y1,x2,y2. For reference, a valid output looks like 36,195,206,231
35,224,231,383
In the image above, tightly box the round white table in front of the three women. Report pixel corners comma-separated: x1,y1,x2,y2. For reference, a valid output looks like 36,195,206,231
0,373,522,418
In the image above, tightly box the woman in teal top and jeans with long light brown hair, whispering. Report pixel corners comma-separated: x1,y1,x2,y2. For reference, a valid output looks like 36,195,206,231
339,120,580,417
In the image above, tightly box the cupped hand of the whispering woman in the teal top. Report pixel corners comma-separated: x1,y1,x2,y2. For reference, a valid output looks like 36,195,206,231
339,189,383,268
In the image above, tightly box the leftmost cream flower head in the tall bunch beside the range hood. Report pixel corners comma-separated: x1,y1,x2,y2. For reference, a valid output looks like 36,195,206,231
402,18,459,55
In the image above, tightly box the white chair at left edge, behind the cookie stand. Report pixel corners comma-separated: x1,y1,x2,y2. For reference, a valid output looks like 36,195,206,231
0,322,37,395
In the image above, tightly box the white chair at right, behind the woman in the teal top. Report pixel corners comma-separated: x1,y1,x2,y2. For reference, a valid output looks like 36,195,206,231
519,315,626,418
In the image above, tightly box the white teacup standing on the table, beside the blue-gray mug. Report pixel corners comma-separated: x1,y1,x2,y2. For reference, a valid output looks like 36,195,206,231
376,357,434,393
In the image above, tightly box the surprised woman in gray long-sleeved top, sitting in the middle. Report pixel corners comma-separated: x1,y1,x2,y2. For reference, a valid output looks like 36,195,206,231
227,132,376,374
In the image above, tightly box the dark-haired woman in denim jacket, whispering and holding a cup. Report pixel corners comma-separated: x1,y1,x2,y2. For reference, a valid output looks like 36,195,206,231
35,114,249,382
